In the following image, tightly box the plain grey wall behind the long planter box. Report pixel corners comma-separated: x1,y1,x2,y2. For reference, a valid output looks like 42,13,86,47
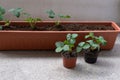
0,0,120,23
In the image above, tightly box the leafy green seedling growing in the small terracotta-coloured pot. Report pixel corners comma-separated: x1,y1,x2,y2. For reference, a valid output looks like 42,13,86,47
55,34,78,52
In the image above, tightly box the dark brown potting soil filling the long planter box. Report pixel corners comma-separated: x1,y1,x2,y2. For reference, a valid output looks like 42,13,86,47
3,24,114,31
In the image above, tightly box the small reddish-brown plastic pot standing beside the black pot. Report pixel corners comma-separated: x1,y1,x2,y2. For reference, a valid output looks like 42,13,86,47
62,56,77,68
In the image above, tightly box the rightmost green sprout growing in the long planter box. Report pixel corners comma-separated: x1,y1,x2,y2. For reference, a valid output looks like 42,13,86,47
47,10,71,26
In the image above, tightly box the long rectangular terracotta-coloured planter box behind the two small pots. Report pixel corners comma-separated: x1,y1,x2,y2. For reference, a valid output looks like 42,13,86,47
0,21,120,50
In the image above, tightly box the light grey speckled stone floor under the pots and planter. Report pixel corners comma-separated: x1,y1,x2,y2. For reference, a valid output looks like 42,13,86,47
0,34,120,80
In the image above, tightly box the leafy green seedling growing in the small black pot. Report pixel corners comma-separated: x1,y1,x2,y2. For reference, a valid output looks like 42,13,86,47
77,32,107,52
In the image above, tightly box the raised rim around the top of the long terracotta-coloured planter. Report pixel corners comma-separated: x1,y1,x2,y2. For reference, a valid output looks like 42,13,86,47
0,21,120,33
